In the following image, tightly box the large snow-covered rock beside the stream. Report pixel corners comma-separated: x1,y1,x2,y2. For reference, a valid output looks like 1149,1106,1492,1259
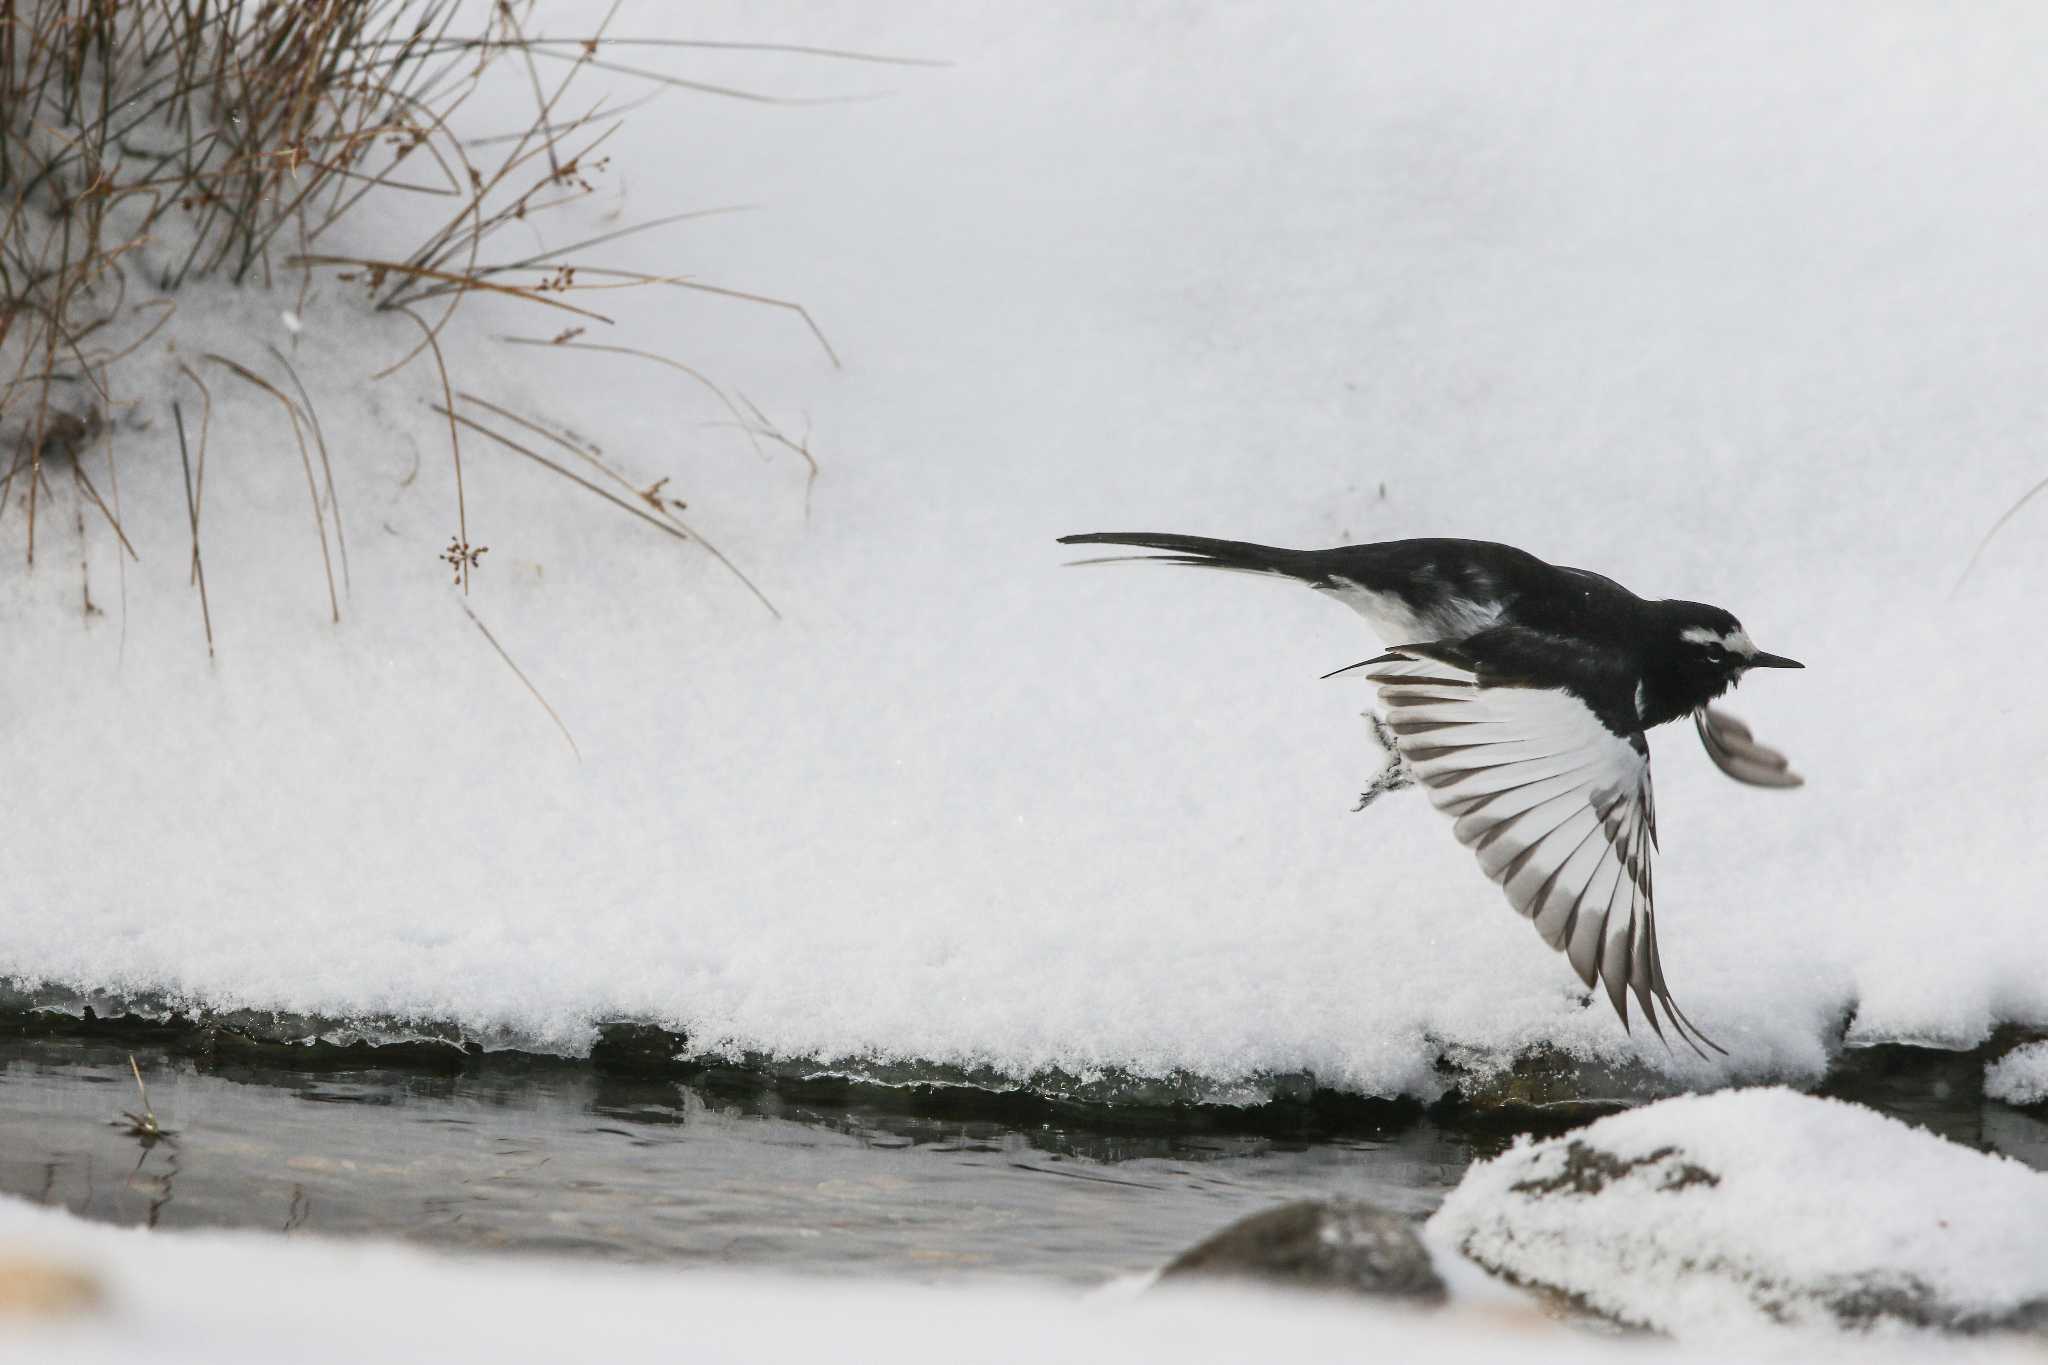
1430,1089,2048,1334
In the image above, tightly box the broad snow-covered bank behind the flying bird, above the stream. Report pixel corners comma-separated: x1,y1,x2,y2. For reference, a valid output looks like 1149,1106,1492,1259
0,0,2048,1093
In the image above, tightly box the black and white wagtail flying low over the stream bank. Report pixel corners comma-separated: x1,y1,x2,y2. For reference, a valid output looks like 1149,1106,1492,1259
1061,530,1804,1056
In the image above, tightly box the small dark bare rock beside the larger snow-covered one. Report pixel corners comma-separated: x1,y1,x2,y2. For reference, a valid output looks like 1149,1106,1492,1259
1159,1199,1444,1304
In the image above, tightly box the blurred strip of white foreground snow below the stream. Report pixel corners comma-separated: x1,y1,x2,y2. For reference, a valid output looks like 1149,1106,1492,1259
0,1199,2032,1365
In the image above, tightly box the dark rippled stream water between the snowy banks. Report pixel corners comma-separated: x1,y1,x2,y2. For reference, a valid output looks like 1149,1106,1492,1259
0,1038,1473,1283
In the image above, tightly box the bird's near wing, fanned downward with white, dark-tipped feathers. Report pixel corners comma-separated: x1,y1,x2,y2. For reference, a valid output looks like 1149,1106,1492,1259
1366,645,1724,1056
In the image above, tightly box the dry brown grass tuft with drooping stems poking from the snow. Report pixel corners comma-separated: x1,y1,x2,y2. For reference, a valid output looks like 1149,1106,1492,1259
0,0,880,630
